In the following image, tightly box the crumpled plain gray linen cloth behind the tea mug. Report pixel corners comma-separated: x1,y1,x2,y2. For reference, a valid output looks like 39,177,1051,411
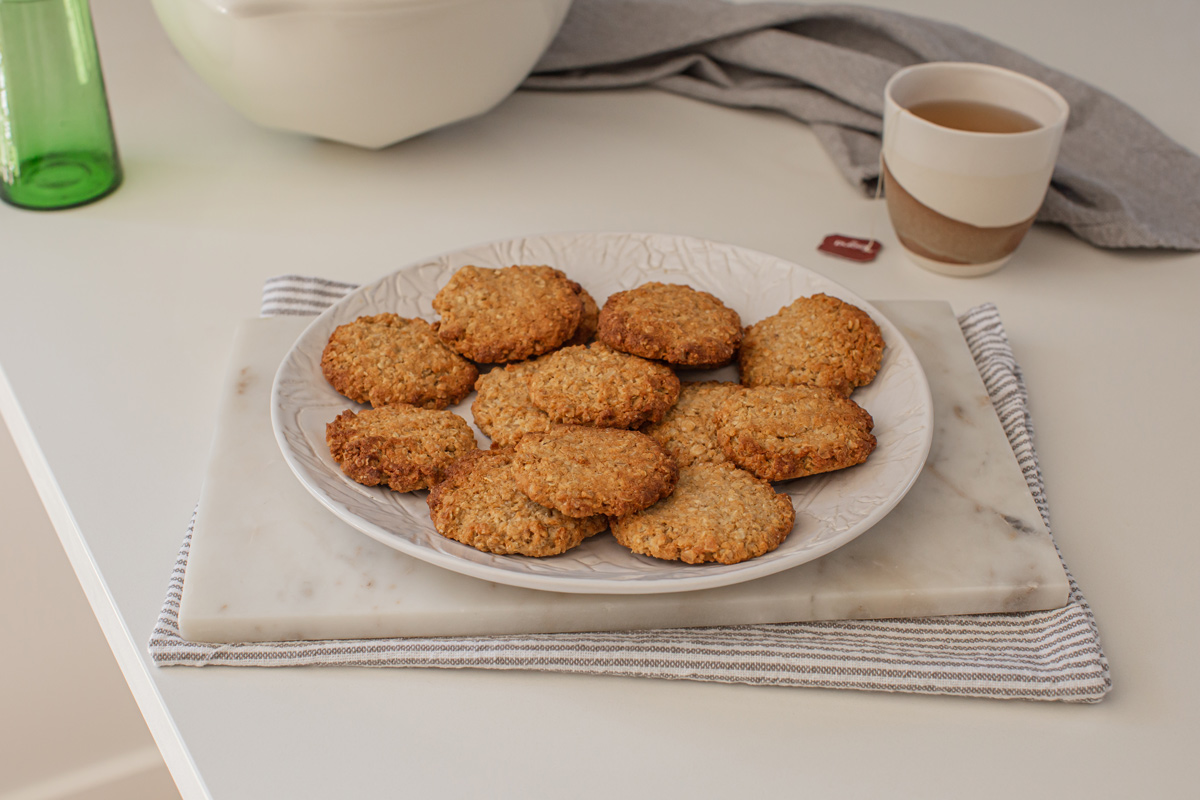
522,0,1200,249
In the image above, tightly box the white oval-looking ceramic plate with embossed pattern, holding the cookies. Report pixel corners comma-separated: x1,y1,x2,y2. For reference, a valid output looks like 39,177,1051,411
271,227,934,594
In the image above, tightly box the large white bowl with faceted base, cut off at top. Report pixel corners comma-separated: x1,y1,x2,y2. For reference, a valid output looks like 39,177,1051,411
154,0,571,148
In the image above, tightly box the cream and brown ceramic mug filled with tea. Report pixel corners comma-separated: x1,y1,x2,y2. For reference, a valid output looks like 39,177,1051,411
881,62,1069,277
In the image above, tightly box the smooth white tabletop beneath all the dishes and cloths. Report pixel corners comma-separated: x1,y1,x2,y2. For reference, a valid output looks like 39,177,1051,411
0,0,1200,800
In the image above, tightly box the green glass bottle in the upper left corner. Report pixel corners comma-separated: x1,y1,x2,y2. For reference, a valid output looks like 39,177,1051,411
0,0,121,209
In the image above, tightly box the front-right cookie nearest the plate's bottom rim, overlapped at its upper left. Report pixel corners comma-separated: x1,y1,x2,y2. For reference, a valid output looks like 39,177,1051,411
610,464,796,564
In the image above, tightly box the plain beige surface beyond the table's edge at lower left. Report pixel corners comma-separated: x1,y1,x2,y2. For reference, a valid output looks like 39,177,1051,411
0,422,179,800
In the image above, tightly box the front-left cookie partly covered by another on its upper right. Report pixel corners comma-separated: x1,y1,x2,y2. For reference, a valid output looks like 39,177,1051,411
426,450,608,558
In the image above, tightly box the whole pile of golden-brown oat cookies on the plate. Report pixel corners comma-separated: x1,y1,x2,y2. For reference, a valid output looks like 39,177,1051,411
322,266,883,564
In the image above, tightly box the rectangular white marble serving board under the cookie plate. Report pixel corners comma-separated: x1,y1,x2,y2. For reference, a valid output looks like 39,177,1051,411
179,301,1068,642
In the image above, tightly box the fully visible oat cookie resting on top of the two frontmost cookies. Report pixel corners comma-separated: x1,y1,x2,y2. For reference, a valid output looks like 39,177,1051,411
514,425,679,517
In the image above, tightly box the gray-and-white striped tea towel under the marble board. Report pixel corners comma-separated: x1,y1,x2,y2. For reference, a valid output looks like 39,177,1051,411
150,276,1112,703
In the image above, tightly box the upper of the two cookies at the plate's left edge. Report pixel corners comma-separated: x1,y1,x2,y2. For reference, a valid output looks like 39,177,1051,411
320,313,479,408
